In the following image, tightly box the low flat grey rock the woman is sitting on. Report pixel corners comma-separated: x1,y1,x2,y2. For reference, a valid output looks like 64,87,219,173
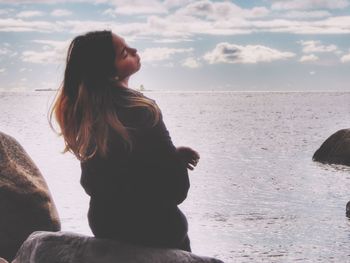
12,232,223,263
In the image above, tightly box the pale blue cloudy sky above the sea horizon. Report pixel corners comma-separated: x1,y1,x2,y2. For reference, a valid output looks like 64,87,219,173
0,0,350,91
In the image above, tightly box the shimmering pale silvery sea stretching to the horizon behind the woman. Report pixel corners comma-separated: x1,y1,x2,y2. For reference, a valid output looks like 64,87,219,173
0,91,350,263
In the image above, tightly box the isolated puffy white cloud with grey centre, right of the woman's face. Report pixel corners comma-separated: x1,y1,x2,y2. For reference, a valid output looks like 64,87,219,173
203,42,295,64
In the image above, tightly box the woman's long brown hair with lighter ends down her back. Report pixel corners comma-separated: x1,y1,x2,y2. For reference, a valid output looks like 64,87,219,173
49,31,160,161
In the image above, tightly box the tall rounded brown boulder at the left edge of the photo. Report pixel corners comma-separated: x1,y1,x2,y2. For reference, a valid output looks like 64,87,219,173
0,132,61,261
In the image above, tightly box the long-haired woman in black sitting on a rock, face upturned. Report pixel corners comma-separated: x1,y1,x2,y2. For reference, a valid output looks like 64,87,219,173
51,31,199,251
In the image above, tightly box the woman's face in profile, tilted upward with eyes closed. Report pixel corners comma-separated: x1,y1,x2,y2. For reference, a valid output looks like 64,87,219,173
112,34,141,80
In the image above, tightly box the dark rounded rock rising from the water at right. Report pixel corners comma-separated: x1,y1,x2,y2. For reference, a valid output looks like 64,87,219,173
312,129,350,166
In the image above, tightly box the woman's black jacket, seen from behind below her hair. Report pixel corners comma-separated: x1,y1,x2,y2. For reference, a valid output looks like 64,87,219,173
81,95,189,250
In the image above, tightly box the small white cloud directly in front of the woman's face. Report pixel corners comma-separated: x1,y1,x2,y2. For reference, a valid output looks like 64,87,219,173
140,47,193,62
